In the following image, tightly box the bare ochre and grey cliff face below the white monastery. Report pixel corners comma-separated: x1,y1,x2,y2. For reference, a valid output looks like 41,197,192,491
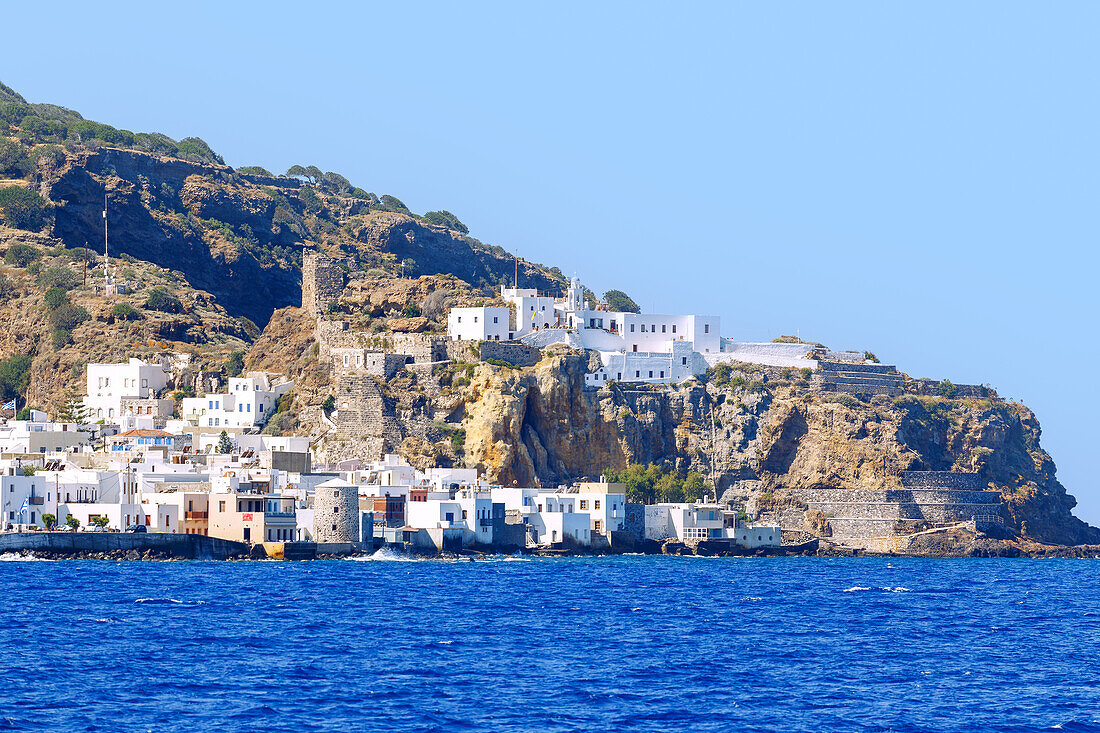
463,353,1100,544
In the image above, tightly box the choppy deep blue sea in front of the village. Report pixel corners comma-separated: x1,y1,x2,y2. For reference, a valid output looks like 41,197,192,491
0,551,1100,732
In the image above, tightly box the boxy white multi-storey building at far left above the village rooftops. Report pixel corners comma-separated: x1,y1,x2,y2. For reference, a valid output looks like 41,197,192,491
84,359,174,423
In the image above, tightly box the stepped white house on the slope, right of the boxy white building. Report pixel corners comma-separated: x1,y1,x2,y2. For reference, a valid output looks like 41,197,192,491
179,372,294,430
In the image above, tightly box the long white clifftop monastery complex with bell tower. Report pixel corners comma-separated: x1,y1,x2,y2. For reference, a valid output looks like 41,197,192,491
447,277,816,386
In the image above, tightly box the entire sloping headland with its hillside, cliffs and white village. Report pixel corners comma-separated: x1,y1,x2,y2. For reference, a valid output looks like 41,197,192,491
0,79,1100,553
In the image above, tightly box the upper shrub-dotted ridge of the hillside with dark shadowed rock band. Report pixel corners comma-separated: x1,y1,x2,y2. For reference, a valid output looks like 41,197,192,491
0,79,562,328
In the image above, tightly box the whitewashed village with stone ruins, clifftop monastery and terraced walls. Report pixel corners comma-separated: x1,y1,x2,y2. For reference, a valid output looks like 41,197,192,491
0,254,1047,554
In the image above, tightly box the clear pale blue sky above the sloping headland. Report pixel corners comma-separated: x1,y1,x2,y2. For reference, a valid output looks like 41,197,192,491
0,0,1100,524
